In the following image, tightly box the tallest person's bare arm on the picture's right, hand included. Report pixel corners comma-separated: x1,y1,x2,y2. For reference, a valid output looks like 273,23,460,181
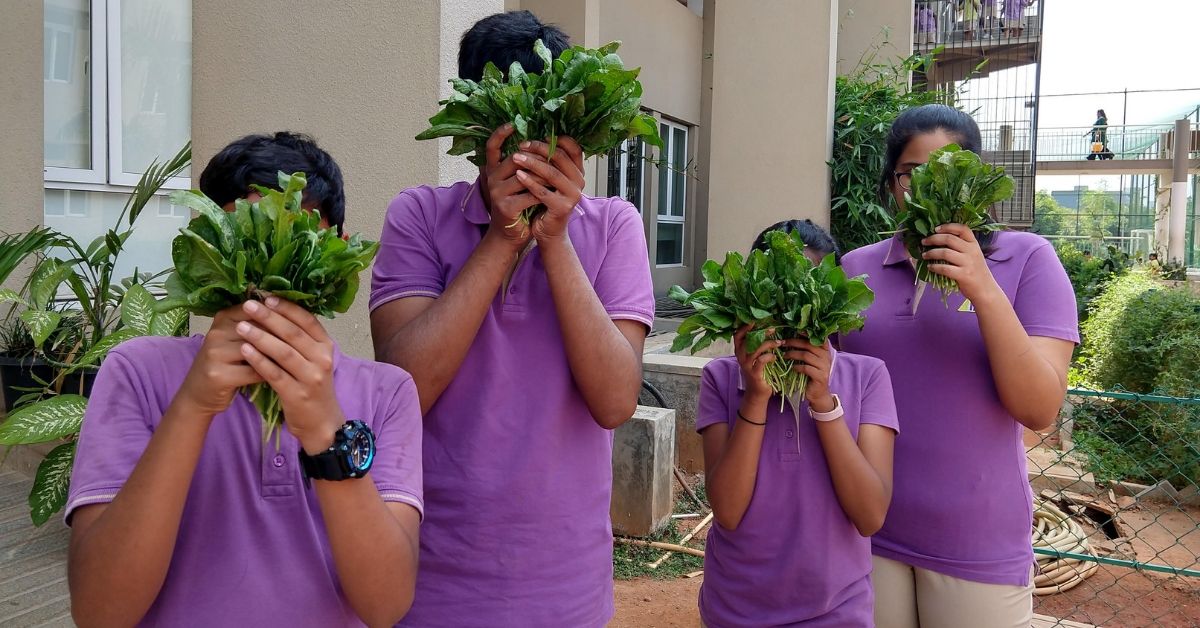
514,137,648,430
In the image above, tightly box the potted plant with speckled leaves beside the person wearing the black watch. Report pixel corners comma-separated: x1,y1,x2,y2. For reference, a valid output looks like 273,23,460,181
0,143,192,525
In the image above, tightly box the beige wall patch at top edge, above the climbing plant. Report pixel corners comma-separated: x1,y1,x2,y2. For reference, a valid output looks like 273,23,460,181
838,0,913,74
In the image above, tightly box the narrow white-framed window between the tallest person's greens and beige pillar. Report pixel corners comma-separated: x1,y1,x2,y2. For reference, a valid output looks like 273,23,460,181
654,121,688,267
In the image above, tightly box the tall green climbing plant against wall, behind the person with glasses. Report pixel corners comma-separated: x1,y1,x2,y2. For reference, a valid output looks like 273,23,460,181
829,47,954,251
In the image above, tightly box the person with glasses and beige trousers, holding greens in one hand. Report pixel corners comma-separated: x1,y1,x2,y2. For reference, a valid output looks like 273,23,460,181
841,104,1079,628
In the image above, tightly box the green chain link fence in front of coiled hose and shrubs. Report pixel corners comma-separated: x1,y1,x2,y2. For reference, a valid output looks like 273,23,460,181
1026,389,1200,627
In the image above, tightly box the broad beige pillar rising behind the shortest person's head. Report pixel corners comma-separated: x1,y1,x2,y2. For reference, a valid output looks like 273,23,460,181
697,0,839,264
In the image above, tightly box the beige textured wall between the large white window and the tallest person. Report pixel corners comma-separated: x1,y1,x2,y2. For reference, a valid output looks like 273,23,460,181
190,0,504,357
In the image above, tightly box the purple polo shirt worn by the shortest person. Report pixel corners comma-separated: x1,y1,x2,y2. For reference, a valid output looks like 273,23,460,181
696,352,899,628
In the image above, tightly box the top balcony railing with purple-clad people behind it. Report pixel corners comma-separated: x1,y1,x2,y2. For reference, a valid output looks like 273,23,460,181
913,0,1044,49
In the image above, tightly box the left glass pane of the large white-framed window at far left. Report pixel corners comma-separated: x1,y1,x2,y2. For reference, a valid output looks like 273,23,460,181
42,0,92,169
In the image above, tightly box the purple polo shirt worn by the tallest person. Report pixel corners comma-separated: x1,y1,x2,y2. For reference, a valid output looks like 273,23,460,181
371,177,654,628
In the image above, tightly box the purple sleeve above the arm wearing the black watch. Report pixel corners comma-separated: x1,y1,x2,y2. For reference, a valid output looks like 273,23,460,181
371,375,425,519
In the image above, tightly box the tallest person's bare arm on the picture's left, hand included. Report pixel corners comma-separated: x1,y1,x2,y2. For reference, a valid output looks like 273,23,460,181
371,125,538,413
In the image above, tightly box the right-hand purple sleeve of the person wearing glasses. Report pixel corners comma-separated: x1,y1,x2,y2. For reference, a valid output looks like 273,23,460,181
1013,243,1079,345
